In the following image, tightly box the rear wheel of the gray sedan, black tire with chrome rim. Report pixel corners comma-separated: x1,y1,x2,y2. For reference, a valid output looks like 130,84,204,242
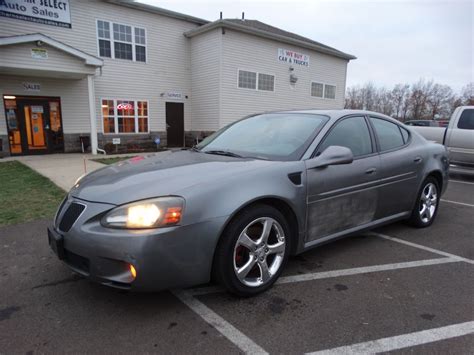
408,176,440,228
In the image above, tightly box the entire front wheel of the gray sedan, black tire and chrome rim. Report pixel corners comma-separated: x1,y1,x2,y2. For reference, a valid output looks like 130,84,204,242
213,204,291,297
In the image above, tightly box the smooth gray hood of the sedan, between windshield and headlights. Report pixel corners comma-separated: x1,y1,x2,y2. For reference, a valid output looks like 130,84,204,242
70,150,274,205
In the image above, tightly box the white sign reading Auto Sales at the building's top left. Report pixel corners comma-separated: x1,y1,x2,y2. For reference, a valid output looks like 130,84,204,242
0,0,71,28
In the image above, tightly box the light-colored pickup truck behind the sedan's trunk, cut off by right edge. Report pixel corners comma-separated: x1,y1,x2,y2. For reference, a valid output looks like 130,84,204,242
413,106,474,167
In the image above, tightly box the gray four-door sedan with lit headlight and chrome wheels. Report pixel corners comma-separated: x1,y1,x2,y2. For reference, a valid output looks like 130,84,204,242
48,110,449,296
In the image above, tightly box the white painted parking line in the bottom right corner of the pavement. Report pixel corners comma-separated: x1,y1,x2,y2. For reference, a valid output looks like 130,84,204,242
310,322,474,355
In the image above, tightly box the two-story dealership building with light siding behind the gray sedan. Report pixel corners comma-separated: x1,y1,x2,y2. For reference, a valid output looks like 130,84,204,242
0,0,355,156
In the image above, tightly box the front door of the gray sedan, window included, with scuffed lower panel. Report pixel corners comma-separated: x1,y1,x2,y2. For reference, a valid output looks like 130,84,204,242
306,115,380,246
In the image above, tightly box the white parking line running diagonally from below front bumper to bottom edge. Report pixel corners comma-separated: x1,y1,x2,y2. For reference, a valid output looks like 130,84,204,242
173,291,268,354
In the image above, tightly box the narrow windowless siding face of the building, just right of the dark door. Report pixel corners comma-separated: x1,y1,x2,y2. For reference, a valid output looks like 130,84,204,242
191,29,222,131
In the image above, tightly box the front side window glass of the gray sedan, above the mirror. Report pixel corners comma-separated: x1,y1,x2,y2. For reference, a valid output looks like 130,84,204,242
317,116,373,158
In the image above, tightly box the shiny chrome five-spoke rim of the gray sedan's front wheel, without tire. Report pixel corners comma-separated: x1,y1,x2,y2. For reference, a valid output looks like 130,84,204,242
234,217,286,287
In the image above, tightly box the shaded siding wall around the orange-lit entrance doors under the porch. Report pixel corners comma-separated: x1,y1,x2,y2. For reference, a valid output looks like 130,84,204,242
0,76,90,134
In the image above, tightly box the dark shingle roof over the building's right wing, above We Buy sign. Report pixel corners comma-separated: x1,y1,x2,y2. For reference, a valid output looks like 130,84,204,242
184,19,356,60
